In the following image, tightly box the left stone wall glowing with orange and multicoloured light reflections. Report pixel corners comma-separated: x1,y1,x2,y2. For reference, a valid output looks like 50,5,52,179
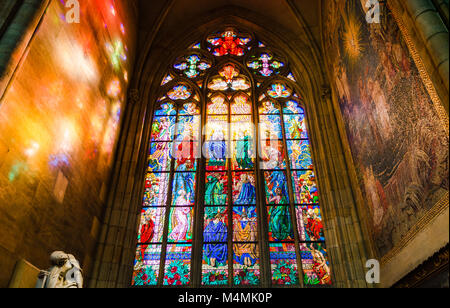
0,0,136,287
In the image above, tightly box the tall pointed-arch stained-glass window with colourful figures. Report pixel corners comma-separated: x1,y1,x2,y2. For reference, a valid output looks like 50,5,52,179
132,28,331,287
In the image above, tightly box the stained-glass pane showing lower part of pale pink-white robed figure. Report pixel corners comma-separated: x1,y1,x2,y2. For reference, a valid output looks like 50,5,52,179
167,207,194,243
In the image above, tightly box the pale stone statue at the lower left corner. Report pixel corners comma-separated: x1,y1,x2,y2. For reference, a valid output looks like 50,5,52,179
36,251,83,289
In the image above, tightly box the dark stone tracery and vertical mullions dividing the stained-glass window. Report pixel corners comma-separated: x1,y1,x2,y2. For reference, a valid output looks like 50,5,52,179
132,27,332,286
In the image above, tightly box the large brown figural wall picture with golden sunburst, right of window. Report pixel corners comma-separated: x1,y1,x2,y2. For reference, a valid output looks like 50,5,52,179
324,0,448,256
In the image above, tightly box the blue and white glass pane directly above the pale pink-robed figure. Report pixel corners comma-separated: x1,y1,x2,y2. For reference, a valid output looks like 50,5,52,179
172,172,195,206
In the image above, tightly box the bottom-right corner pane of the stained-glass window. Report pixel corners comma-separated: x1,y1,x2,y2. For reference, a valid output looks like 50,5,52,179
300,243,332,286
